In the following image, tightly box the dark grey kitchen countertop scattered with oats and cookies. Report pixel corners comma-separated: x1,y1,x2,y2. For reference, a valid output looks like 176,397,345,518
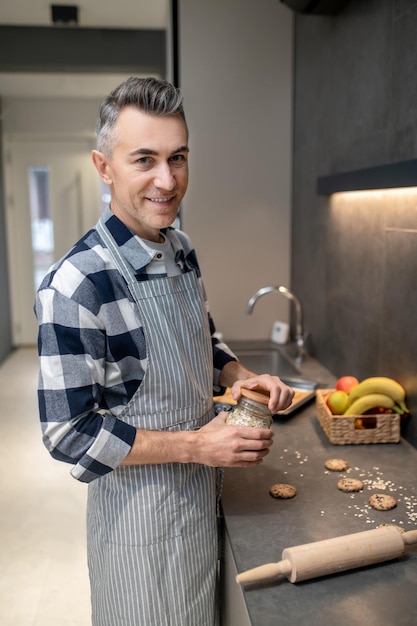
222,348,417,626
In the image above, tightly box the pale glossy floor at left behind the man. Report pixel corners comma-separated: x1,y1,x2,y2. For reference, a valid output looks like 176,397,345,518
0,348,91,626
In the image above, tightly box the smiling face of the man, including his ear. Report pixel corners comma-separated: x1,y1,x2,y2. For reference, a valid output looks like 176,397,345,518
93,106,188,241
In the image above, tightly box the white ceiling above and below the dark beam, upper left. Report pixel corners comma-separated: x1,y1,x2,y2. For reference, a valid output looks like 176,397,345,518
0,0,171,98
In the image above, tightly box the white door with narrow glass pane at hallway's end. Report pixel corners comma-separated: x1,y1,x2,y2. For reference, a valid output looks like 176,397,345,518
5,138,102,347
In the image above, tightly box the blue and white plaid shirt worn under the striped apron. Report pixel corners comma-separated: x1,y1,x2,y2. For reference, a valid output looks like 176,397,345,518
35,209,235,482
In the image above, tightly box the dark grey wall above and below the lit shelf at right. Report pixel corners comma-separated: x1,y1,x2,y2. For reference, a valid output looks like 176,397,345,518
292,0,417,445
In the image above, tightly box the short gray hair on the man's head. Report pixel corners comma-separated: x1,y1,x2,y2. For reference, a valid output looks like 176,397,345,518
96,76,187,158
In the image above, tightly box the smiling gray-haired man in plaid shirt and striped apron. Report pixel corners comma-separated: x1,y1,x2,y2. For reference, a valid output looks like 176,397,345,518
36,77,292,626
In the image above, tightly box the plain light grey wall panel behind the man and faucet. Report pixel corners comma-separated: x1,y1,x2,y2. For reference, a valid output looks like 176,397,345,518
179,0,293,340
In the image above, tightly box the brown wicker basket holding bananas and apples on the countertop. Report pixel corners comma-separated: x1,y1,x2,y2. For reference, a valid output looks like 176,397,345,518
316,389,401,446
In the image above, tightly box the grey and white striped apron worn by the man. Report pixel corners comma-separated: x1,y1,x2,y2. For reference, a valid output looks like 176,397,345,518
87,221,218,626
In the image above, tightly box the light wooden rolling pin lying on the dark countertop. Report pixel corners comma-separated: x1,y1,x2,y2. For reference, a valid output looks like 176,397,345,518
236,526,417,585
